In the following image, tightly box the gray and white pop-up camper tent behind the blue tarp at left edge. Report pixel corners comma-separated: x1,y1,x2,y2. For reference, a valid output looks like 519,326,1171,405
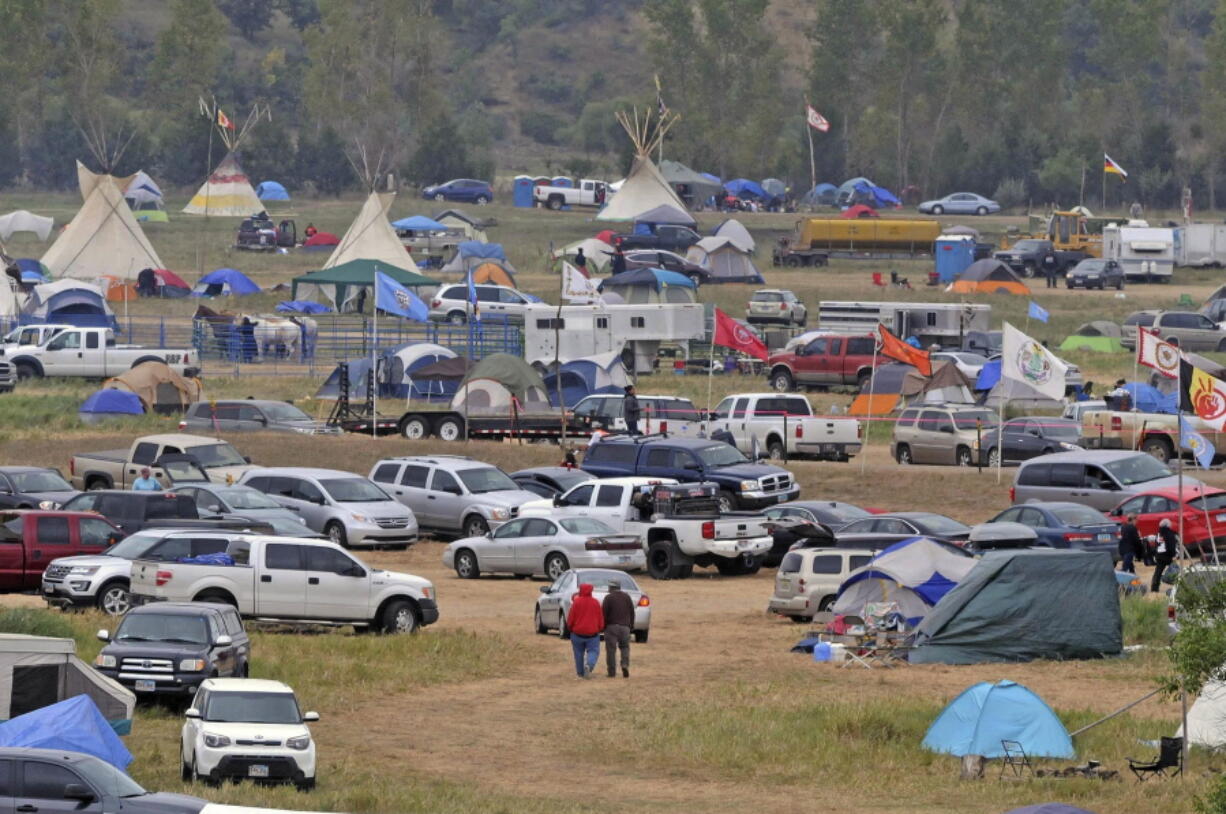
0,633,136,734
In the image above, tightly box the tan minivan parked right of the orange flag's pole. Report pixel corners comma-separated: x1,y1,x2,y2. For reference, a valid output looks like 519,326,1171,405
890,405,999,466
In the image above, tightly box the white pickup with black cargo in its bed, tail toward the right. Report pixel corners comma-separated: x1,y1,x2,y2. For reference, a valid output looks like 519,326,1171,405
520,477,772,580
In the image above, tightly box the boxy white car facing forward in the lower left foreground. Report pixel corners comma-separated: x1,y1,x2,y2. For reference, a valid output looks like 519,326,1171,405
179,678,319,791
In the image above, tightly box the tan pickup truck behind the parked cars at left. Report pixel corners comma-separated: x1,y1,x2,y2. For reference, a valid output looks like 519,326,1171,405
69,433,257,489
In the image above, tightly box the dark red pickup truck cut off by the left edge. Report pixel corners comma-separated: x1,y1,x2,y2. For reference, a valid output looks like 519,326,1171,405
0,510,124,591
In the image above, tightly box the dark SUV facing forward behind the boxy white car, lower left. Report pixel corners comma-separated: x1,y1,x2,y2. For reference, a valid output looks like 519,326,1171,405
93,602,251,695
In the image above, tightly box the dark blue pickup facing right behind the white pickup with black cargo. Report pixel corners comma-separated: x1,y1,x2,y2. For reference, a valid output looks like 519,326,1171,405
582,436,801,514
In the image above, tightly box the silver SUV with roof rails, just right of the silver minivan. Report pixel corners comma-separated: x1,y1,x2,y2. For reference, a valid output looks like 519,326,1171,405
370,455,538,537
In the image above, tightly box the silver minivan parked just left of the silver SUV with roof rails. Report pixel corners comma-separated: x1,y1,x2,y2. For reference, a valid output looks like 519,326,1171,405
236,466,417,550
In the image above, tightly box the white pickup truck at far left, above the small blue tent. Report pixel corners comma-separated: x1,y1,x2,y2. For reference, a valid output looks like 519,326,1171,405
9,327,200,379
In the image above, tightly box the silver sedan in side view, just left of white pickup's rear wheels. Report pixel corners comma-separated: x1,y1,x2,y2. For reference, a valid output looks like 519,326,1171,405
443,517,647,580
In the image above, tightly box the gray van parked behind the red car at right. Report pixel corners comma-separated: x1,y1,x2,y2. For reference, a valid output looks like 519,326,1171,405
1009,450,1200,511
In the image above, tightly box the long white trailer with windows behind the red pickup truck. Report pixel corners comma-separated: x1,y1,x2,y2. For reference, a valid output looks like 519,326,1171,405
818,300,992,348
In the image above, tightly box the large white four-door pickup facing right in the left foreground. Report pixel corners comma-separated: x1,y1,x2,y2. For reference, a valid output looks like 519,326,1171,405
131,534,439,633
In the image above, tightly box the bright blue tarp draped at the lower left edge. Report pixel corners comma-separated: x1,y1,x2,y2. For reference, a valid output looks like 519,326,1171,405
0,695,132,770
